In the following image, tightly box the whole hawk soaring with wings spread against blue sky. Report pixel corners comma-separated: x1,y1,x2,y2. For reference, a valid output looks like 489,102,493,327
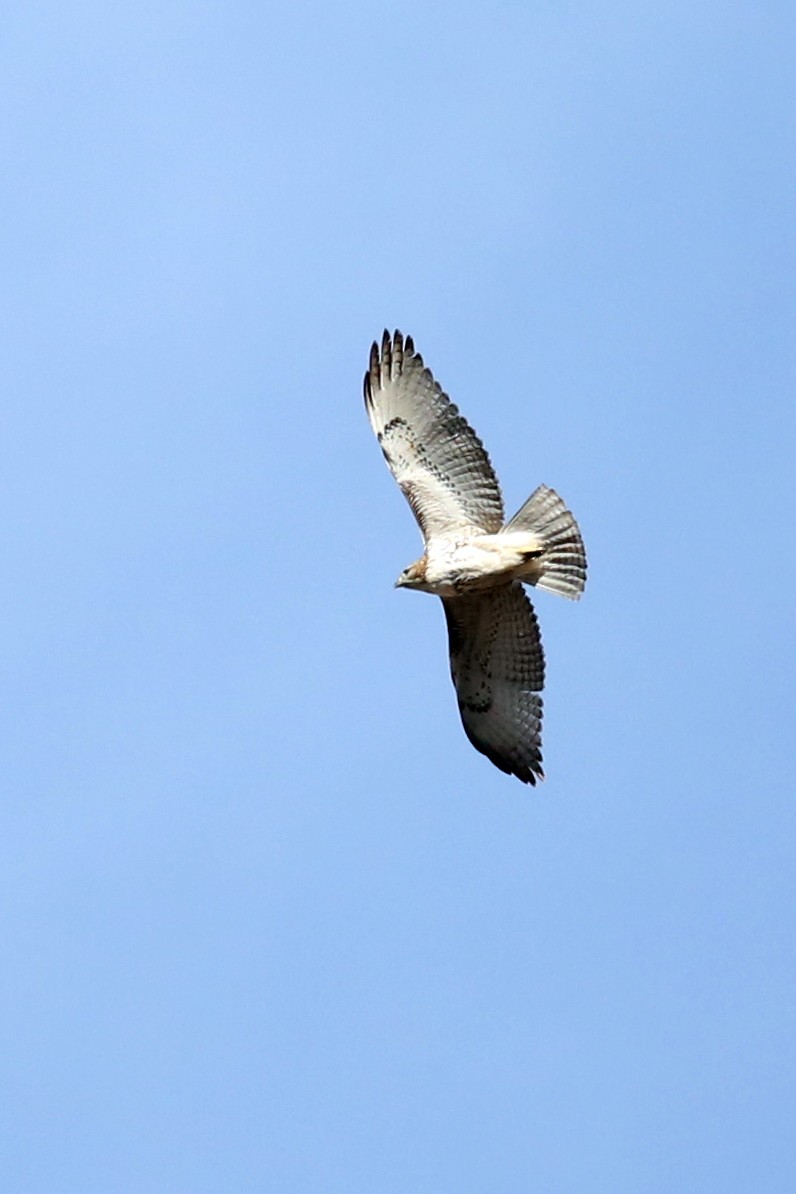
365,332,586,783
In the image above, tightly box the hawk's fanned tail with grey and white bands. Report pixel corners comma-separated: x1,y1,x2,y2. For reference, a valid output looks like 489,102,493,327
501,485,586,601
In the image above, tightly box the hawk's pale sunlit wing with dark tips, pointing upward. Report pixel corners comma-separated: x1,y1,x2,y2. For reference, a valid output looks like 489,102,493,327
365,332,504,541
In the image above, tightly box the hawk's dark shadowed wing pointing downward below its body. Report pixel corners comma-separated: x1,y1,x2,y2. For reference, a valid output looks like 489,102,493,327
443,581,544,783
